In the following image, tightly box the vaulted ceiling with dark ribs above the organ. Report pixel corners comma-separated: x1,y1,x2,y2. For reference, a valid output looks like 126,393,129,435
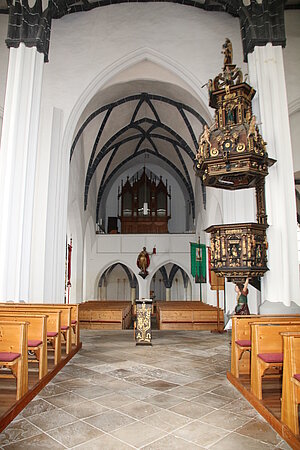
70,80,206,218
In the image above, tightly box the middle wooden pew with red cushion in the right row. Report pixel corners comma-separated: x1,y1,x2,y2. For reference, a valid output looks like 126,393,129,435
251,321,300,400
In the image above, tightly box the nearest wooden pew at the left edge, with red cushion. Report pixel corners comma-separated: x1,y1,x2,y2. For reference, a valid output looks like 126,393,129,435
0,320,28,400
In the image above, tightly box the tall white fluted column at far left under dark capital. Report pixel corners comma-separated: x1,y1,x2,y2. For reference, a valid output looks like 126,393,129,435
0,43,44,301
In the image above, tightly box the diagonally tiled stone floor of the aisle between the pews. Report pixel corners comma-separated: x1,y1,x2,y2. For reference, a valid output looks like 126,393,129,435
0,330,290,450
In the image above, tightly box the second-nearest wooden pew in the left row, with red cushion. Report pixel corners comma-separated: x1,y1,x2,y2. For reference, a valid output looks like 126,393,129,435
0,311,48,380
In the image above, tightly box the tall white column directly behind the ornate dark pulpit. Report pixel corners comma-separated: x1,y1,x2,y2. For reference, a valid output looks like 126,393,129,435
248,44,300,306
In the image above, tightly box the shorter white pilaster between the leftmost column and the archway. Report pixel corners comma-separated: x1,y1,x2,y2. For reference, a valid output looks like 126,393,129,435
31,102,65,303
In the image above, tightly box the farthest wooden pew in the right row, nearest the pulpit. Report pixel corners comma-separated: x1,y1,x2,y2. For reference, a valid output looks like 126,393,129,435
230,314,300,378
